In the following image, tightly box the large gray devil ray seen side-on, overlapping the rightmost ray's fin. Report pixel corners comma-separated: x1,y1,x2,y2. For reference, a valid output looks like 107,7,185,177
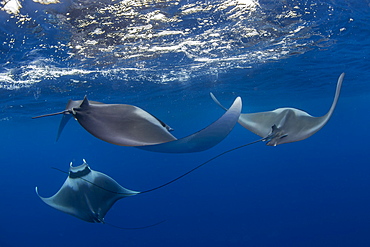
34,97,242,153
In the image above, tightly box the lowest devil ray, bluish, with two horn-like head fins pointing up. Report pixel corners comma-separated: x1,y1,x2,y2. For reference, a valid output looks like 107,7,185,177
36,160,140,223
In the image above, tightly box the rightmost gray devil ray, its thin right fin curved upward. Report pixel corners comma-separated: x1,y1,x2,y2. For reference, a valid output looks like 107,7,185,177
211,73,344,146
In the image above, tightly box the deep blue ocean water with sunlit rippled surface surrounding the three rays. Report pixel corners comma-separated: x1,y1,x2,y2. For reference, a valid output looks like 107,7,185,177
0,0,370,247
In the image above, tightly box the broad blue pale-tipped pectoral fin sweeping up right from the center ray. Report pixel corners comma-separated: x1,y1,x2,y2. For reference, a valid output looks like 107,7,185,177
137,97,242,153
